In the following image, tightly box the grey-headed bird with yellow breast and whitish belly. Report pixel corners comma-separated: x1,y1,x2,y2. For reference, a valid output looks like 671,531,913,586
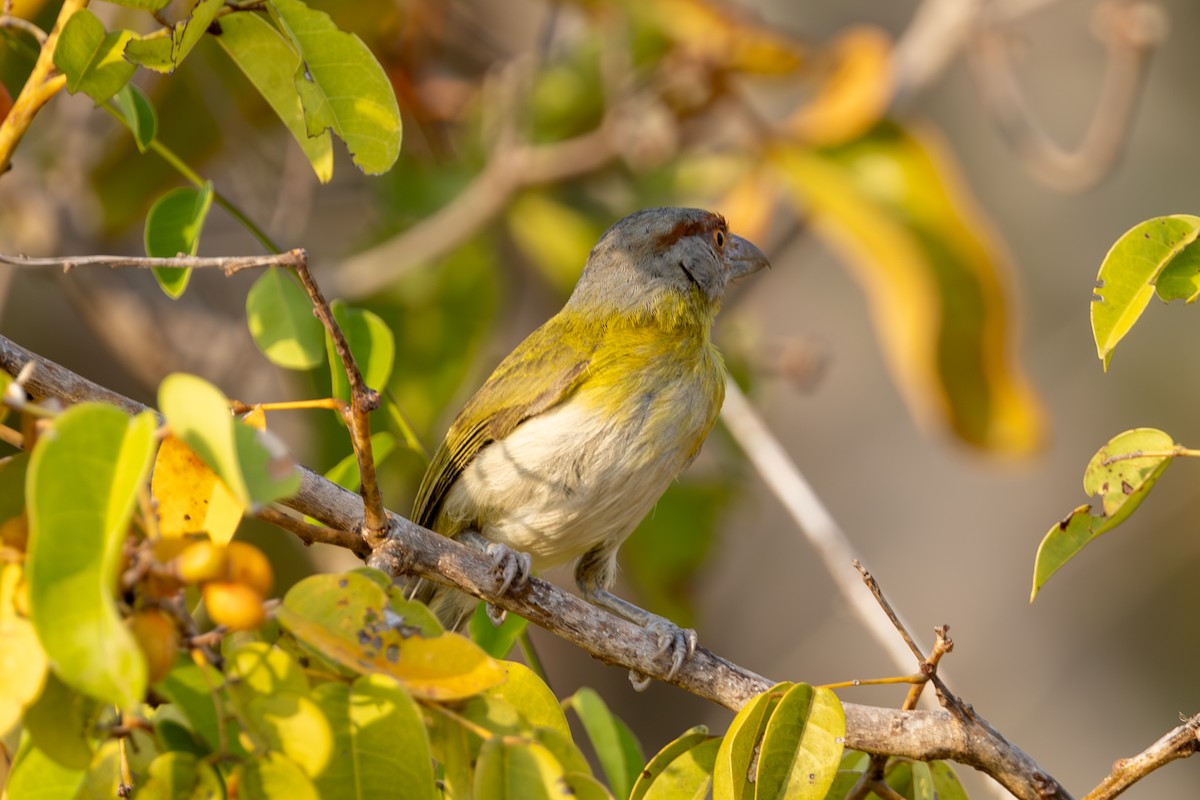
412,207,769,688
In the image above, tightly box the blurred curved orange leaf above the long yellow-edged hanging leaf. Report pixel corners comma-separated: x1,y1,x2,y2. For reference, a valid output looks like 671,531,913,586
787,25,893,145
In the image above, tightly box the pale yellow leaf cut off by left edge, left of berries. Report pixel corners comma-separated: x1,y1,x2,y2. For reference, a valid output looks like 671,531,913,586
0,564,46,738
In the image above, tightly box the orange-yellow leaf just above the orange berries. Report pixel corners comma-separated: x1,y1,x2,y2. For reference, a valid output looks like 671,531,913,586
150,437,246,545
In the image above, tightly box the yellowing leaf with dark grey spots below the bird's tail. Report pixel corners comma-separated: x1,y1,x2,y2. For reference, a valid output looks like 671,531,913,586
276,572,504,700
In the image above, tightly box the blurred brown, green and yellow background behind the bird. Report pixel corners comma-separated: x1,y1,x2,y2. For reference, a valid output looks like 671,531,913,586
0,0,1200,798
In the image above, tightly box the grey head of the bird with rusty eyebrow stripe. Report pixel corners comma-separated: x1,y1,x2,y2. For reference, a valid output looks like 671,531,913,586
566,209,769,323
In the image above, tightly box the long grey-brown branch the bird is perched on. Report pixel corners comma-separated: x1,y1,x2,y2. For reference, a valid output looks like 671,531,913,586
0,328,1089,800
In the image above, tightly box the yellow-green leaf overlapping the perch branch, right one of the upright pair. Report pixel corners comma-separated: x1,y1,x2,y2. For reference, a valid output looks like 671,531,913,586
755,684,846,800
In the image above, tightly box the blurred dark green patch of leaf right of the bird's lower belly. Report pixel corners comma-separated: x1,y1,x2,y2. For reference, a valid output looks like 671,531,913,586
620,475,738,627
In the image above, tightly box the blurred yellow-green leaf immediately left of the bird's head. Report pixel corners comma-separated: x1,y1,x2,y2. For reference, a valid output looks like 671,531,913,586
508,192,604,296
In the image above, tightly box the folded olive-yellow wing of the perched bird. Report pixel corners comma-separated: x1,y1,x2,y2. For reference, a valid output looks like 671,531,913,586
413,315,599,528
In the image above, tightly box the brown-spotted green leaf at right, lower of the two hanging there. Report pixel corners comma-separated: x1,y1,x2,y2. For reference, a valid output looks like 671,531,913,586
1030,428,1180,602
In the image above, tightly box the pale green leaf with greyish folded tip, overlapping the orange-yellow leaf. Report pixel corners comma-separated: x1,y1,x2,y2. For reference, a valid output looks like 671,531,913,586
158,373,300,506
